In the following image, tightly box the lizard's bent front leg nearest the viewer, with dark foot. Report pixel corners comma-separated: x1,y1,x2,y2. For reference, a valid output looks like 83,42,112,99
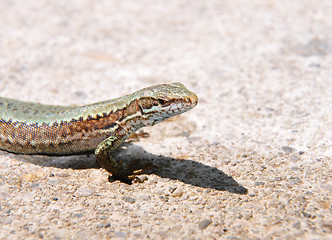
95,136,137,182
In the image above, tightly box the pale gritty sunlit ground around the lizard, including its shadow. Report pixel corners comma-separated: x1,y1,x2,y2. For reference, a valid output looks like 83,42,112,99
0,0,332,239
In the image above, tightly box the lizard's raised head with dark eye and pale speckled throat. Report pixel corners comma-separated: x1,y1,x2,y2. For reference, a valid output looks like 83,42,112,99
136,83,198,125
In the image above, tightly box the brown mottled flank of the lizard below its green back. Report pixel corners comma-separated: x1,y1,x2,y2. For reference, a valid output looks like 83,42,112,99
0,99,147,154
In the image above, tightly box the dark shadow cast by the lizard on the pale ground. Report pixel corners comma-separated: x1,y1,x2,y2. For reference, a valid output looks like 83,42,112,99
6,143,248,194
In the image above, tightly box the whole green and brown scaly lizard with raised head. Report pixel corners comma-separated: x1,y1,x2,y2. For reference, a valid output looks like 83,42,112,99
0,83,198,179
